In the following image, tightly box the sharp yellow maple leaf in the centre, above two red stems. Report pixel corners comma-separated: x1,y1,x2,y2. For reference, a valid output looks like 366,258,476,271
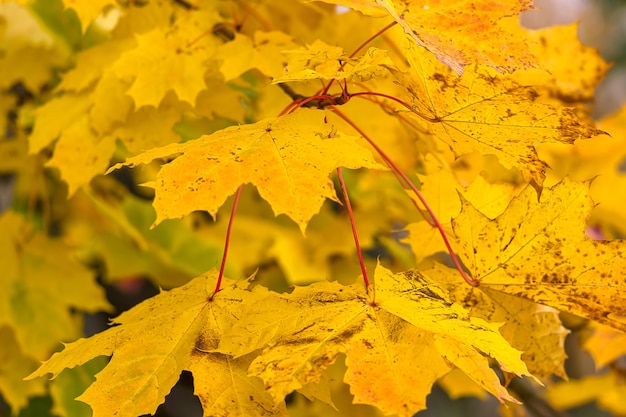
109,109,384,231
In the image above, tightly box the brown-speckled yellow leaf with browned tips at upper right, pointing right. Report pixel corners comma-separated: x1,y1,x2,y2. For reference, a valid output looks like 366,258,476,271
390,46,602,185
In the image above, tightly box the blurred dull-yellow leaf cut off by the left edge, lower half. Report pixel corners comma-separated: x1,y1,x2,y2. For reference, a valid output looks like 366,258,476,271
0,211,111,359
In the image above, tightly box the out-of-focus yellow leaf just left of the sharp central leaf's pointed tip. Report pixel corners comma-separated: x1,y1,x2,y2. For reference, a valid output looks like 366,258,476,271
28,82,184,195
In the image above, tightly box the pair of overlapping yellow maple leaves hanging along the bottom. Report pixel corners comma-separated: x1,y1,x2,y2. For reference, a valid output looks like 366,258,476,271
31,266,529,417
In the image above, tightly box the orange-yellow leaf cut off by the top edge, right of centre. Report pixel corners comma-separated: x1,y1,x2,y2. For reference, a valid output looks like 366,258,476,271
371,0,536,74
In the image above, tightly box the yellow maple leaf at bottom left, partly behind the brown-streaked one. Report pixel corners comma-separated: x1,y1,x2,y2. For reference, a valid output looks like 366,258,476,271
28,271,286,417
